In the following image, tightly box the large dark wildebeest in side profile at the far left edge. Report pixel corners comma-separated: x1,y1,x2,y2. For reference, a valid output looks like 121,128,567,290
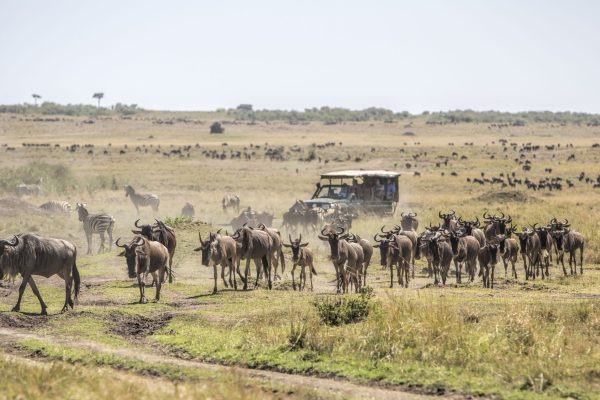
0,233,81,315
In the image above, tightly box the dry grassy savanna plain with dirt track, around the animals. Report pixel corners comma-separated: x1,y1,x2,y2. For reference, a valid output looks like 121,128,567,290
0,112,600,399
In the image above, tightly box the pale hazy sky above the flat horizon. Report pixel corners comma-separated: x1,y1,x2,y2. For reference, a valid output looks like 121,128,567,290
0,0,600,113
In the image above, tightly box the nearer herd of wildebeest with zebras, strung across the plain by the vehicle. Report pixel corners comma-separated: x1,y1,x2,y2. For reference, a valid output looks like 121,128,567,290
0,177,584,314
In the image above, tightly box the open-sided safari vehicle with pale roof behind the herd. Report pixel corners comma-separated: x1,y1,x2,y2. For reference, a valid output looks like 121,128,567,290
304,170,400,215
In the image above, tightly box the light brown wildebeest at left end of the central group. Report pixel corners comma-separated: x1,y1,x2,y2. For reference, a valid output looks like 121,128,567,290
194,232,241,294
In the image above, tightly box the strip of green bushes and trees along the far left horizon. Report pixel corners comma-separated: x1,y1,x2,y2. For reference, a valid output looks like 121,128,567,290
0,99,142,116
